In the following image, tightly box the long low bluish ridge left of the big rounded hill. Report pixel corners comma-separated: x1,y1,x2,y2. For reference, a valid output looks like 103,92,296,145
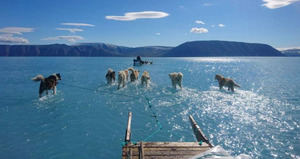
0,43,171,57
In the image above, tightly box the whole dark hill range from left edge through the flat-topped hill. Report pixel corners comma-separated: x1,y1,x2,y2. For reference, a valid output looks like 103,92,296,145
0,41,284,57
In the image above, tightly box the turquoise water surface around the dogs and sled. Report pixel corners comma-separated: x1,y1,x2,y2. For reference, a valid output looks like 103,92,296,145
0,57,300,159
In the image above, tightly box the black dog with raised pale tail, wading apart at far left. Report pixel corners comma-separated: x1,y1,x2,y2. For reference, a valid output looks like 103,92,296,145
32,73,61,97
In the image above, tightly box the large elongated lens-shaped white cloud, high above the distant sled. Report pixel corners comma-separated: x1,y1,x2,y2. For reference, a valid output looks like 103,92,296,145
105,11,169,21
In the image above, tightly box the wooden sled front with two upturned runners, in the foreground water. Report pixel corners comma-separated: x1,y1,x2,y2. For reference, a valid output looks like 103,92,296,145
122,112,213,159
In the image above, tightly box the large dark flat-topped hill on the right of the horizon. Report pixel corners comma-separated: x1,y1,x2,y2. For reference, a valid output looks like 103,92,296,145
165,41,284,57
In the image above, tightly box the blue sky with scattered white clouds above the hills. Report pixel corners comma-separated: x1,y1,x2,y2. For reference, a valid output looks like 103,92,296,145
0,0,300,48
